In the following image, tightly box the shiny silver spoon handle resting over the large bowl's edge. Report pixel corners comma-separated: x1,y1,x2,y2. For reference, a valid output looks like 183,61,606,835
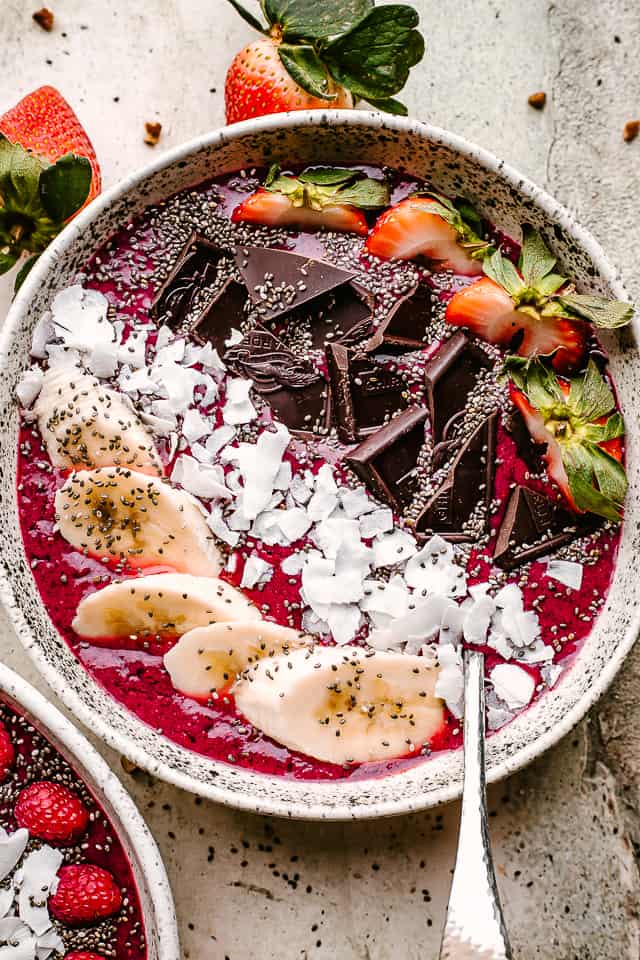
440,650,512,960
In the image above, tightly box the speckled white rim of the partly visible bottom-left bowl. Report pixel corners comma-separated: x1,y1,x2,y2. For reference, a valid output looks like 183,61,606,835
0,663,180,960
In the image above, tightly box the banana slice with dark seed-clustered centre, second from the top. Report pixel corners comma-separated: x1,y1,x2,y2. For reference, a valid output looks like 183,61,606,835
55,467,222,577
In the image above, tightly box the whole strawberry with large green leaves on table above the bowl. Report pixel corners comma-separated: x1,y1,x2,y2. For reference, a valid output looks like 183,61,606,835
225,0,424,123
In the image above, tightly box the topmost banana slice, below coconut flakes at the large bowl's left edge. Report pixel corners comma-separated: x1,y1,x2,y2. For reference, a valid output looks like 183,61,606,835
33,367,162,475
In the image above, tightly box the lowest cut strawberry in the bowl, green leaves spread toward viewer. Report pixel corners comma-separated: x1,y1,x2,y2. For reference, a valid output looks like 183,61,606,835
505,357,627,521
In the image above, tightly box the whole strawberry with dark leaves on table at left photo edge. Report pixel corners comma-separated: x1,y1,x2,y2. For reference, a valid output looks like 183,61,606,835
0,87,100,288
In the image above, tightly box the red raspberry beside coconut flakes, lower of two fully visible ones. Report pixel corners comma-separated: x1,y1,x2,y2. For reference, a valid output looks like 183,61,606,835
49,863,122,926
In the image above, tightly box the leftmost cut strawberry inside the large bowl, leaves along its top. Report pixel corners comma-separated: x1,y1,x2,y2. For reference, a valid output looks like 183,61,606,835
231,164,389,236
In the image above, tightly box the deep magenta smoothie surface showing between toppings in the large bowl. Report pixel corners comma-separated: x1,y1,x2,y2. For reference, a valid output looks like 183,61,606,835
18,163,619,780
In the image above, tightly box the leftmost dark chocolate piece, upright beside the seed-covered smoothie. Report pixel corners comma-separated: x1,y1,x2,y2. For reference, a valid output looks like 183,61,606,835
151,233,230,329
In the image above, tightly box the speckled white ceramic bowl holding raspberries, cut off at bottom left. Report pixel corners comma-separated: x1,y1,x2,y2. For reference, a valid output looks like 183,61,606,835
0,663,180,960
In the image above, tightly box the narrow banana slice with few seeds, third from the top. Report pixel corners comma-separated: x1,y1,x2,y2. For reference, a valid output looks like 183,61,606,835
71,573,260,638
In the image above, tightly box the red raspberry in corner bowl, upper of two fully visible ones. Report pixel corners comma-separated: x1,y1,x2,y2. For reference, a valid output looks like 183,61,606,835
14,780,89,843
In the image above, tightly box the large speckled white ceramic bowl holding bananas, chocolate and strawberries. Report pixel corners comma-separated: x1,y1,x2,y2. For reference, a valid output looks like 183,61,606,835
0,111,640,819
